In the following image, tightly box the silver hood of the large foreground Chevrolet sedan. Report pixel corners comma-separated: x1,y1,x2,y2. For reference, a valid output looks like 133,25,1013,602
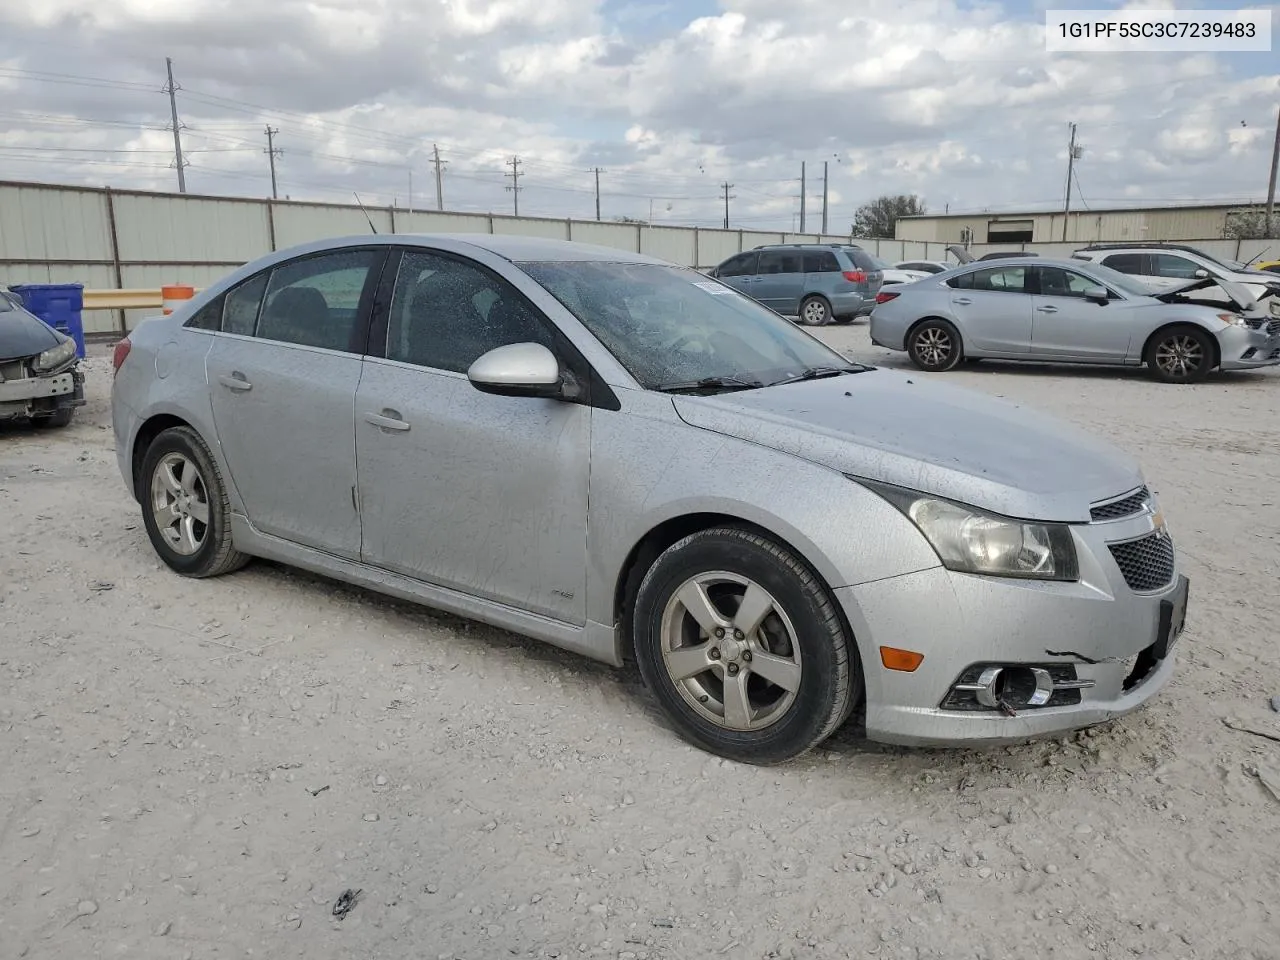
673,370,1143,522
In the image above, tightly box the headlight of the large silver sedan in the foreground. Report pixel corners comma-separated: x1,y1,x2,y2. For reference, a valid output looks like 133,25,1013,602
851,477,1080,581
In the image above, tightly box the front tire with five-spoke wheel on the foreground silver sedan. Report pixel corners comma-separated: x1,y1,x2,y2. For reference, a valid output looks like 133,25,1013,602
632,526,860,764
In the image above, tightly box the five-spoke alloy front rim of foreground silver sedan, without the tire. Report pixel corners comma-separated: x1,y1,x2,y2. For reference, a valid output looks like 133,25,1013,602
660,571,801,731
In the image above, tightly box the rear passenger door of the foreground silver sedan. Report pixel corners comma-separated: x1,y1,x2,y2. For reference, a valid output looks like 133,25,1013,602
205,248,385,558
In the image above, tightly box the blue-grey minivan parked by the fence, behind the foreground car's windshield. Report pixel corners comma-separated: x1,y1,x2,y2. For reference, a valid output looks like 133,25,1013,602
710,243,884,326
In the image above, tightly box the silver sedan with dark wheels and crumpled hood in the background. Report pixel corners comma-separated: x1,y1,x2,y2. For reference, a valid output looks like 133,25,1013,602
870,259,1280,383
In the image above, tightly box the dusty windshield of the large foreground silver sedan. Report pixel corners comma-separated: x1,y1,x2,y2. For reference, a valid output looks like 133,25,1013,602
520,261,849,389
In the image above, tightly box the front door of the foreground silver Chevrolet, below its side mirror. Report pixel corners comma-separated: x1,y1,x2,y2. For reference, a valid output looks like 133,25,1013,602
356,250,591,625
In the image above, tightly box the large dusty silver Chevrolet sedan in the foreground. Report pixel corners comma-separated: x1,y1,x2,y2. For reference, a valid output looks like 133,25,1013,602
111,234,1187,763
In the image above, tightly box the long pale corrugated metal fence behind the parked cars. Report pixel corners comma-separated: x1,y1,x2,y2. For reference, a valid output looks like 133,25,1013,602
0,183,1268,333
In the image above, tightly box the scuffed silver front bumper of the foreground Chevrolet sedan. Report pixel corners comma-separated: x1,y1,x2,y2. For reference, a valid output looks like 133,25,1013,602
836,513,1181,746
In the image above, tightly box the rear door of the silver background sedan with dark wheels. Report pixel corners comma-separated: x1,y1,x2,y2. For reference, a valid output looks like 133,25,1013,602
947,262,1032,353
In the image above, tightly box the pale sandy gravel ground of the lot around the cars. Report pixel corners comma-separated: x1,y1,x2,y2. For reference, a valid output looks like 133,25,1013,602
0,325,1280,960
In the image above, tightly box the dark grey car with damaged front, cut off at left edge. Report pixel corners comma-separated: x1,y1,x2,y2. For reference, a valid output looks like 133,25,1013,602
0,288,84,426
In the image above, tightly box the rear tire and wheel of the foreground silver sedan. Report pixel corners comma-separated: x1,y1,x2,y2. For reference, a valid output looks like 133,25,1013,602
138,426,248,577
